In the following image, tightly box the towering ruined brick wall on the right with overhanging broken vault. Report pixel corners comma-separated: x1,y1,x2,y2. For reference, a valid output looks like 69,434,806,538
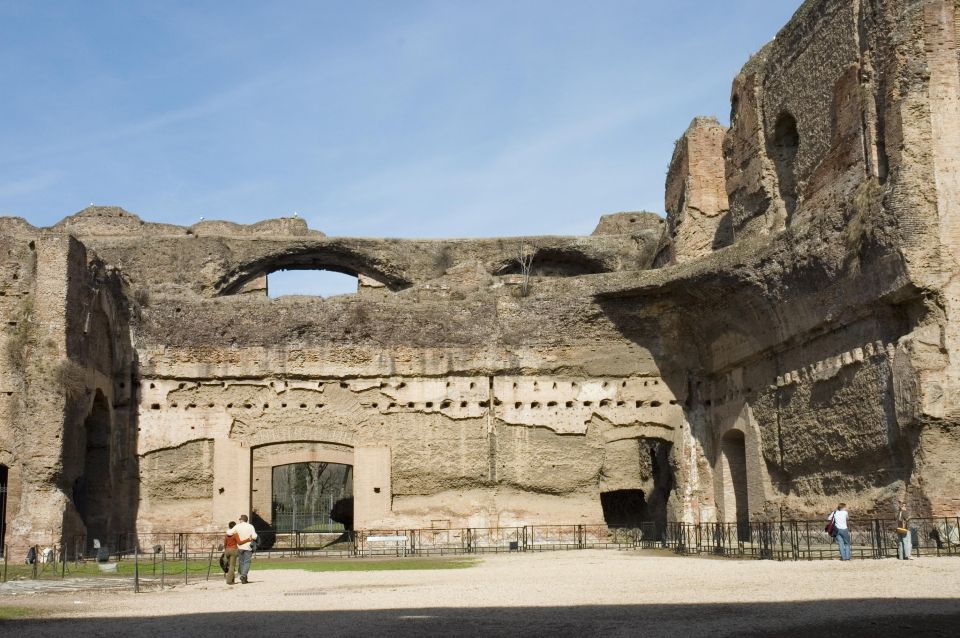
632,0,960,515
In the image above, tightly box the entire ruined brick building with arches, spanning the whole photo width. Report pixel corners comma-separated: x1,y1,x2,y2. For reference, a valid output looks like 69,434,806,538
0,0,960,556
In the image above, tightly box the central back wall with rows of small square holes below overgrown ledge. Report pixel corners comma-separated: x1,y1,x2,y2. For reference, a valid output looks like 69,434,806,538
129,276,684,530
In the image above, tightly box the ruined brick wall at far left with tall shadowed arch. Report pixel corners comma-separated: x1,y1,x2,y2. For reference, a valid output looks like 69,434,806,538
0,220,137,553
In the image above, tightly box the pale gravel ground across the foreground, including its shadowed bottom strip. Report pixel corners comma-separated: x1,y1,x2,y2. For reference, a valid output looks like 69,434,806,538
0,550,960,638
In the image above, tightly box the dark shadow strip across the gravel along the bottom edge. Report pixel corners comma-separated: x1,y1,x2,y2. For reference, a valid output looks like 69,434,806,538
0,604,960,638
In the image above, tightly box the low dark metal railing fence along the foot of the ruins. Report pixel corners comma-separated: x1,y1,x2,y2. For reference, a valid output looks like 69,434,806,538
2,517,960,591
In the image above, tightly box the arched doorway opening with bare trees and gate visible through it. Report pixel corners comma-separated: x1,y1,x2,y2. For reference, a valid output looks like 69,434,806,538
271,462,353,533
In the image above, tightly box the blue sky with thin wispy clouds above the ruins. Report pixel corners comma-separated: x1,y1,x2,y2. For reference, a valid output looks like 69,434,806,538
0,0,799,296
